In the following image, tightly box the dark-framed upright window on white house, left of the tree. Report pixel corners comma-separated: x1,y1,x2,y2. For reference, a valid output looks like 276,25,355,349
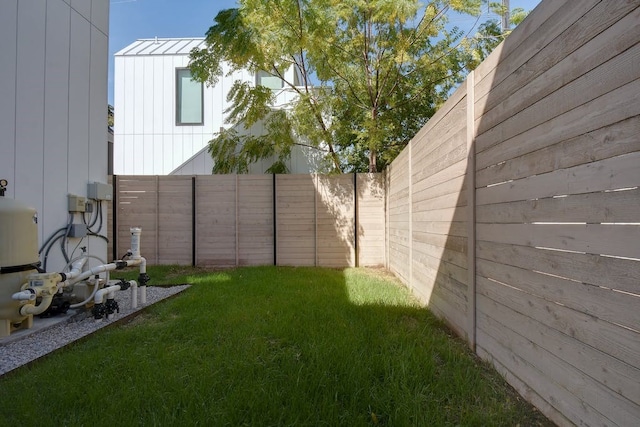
176,68,204,126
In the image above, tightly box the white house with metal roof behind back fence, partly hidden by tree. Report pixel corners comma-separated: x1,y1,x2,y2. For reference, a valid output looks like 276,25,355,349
113,38,313,175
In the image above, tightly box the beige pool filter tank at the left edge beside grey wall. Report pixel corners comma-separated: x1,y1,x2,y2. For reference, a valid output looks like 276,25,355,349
0,180,40,337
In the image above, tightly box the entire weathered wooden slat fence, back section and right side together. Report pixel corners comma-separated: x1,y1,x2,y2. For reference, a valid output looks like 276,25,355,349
109,0,640,426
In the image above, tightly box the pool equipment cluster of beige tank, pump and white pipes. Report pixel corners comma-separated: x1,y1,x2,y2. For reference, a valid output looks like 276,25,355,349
0,180,149,338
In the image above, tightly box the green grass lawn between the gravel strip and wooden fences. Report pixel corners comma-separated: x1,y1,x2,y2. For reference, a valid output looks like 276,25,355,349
0,267,551,426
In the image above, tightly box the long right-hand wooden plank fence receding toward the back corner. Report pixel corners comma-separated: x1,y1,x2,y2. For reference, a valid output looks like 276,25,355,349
386,0,640,426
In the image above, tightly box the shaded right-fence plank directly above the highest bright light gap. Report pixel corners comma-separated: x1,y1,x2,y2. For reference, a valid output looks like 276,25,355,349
476,151,640,205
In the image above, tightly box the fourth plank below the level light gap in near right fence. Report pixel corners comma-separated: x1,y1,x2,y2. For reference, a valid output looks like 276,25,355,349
476,276,640,366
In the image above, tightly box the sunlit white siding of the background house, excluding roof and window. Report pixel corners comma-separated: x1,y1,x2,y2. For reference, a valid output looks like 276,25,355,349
114,50,254,175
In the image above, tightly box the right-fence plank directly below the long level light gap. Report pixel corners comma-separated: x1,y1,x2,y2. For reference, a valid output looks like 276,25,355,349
477,224,640,259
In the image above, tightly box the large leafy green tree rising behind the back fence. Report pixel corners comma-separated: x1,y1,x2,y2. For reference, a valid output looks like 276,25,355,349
190,0,480,173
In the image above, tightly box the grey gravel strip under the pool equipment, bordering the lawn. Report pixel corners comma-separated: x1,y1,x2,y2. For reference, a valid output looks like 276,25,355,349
0,285,189,376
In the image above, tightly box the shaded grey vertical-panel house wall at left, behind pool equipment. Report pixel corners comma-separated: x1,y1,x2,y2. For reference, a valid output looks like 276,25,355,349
0,0,109,271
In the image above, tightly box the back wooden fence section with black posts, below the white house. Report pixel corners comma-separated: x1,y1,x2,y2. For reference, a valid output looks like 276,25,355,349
108,174,385,267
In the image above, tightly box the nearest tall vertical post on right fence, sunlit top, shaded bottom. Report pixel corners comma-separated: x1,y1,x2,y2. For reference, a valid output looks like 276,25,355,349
466,71,476,352
